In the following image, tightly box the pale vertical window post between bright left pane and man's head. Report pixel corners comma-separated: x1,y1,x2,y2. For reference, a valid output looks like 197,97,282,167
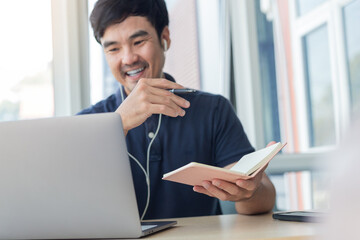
51,0,90,116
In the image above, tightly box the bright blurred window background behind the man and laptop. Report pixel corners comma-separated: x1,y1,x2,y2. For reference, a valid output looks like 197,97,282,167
0,0,360,212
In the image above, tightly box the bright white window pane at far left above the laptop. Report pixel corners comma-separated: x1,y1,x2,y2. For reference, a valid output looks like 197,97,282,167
0,0,54,121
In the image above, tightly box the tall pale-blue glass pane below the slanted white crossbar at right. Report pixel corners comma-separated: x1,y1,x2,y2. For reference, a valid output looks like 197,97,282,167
303,25,336,147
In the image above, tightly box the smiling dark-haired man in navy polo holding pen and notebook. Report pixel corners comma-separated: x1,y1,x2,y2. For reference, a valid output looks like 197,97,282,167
80,0,275,219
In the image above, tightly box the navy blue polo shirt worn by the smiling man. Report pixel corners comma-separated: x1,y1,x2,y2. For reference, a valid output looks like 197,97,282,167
79,74,254,219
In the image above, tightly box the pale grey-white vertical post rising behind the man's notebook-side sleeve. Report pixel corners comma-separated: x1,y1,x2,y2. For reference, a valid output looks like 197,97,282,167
229,0,267,149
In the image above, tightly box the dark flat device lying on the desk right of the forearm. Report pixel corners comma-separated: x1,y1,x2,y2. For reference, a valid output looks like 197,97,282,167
273,211,326,222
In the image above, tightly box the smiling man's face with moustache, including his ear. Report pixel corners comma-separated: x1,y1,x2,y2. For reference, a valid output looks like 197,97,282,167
101,16,170,94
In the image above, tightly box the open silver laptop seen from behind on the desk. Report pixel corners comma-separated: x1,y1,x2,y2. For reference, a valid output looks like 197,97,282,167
0,113,176,239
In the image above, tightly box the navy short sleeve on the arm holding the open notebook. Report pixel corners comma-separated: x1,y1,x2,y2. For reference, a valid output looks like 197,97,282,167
213,96,254,167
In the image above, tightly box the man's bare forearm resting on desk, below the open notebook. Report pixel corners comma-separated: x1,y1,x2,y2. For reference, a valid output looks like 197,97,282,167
235,174,276,214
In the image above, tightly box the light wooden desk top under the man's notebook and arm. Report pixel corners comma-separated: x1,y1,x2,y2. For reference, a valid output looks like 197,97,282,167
145,214,319,240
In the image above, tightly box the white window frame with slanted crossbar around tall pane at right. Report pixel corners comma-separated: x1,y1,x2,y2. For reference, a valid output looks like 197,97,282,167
289,0,352,152
